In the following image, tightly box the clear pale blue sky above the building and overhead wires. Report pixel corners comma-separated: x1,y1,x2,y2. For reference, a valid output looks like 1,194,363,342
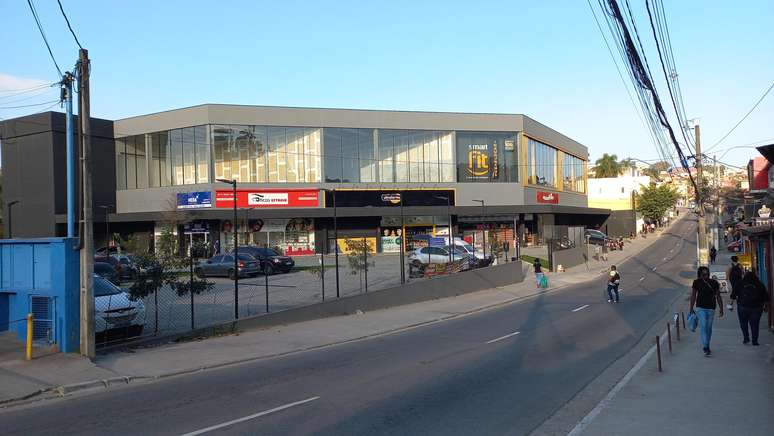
0,0,774,169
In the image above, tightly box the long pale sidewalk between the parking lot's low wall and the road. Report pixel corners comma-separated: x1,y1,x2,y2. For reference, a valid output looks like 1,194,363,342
0,215,688,406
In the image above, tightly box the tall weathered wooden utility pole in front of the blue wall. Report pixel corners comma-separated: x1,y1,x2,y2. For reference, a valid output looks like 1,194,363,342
78,48,96,360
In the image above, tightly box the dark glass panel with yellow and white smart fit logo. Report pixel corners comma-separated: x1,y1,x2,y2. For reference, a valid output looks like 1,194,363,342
457,131,519,183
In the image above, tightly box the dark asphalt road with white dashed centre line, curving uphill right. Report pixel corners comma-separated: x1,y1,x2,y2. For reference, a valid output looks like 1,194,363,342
0,220,695,435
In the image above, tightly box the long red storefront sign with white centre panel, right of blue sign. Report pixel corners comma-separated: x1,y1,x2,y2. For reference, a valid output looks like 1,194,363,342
215,189,320,208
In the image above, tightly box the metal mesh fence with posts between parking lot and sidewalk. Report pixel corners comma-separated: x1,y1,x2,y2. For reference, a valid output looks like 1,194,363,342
95,245,504,347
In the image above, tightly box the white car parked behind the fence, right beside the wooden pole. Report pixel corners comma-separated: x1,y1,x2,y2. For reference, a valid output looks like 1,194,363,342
94,274,145,342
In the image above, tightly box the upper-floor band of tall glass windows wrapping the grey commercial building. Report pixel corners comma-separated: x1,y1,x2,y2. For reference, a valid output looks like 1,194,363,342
115,124,586,192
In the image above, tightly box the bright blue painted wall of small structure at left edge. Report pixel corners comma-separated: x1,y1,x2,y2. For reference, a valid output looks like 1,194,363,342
0,238,80,353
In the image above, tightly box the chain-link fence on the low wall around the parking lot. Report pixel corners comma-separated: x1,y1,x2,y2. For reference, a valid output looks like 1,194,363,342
95,242,504,346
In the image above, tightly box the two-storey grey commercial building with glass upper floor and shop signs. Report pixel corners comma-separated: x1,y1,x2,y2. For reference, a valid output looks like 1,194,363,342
0,104,609,255
